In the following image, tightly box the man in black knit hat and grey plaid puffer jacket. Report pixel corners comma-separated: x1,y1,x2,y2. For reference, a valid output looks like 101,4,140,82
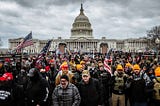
52,75,81,106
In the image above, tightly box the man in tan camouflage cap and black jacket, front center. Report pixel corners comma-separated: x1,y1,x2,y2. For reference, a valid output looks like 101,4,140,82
78,70,103,106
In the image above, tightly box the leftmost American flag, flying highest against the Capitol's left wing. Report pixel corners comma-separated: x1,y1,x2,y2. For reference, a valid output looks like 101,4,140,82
16,32,33,50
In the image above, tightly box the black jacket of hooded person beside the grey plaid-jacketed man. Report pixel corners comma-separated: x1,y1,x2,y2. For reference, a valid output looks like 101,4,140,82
26,77,49,106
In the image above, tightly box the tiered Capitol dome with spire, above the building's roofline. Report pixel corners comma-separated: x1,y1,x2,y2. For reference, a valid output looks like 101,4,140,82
70,4,93,39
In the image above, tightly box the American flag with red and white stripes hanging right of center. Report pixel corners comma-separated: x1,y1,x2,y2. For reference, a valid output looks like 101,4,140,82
104,49,112,75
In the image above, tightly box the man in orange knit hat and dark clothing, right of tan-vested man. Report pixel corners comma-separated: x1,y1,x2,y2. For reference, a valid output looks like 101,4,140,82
130,64,151,106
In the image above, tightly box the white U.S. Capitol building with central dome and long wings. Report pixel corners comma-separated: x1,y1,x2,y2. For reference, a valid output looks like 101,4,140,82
9,4,147,53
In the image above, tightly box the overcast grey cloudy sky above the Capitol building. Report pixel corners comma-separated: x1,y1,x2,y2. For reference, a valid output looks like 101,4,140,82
0,0,160,47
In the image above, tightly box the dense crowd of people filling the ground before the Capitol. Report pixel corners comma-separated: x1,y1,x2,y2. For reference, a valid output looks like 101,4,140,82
0,52,160,106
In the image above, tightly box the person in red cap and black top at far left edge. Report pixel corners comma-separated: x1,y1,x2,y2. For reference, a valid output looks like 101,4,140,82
0,72,25,106
